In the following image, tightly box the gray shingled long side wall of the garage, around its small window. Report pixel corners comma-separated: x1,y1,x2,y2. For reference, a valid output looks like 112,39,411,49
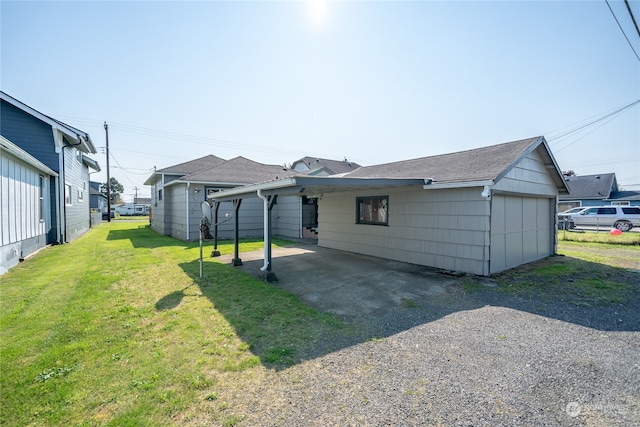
318,188,489,274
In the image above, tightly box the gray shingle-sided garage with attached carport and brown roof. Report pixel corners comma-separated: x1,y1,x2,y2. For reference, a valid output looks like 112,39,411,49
211,137,568,275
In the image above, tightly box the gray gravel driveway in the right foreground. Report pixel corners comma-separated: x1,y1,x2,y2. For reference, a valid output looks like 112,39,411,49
222,246,640,426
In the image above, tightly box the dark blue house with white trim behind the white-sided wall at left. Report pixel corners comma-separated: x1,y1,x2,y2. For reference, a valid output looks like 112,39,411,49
0,92,100,256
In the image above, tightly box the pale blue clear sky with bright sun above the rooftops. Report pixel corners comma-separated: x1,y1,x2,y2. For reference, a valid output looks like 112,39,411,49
0,0,640,200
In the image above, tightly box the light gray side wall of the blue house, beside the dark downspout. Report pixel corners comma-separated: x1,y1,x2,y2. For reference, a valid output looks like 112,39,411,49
62,146,91,242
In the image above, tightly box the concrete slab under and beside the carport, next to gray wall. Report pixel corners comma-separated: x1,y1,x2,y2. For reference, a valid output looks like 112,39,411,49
218,243,461,319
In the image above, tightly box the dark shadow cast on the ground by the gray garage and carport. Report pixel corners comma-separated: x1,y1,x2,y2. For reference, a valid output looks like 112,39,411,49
166,248,640,369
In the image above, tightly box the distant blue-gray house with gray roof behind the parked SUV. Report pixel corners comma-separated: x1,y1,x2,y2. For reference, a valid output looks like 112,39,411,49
558,173,640,212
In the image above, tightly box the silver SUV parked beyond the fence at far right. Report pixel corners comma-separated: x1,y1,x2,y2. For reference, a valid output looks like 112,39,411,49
570,205,640,231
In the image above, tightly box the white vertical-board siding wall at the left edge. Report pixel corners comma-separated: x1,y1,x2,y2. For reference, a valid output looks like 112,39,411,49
0,147,51,274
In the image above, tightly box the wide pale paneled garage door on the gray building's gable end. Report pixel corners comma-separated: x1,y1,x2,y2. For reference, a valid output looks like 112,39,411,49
489,195,555,273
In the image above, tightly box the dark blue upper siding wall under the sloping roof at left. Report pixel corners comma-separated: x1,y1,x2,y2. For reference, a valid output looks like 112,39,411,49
0,101,60,173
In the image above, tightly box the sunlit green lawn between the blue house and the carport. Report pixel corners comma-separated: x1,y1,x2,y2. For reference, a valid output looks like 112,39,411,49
0,221,342,426
